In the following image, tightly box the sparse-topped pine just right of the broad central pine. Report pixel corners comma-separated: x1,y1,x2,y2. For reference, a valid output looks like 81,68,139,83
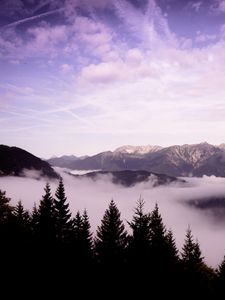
128,197,151,267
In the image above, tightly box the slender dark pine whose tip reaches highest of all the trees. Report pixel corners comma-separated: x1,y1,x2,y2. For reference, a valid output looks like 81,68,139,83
54,178,71,242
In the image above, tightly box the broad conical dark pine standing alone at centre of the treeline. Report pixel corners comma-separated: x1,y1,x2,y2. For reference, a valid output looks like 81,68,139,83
95,200,127,267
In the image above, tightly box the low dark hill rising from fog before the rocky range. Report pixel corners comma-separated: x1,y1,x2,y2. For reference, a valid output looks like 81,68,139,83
73,170,185,187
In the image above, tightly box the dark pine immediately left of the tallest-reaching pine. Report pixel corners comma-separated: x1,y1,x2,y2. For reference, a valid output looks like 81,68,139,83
37,183,56,244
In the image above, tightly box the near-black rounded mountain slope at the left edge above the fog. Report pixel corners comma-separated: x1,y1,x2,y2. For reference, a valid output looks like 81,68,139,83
0,145,59,178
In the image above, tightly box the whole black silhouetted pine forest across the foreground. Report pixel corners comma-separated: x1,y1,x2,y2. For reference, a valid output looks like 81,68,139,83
0,180,225,298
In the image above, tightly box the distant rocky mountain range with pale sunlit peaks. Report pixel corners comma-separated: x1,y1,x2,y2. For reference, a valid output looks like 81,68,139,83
48,143,225,177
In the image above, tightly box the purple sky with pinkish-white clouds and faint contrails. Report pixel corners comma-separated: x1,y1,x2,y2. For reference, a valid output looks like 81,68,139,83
0,0,225,158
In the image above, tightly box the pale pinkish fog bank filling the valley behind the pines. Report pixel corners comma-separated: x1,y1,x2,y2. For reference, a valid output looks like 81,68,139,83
0,168,225,267
